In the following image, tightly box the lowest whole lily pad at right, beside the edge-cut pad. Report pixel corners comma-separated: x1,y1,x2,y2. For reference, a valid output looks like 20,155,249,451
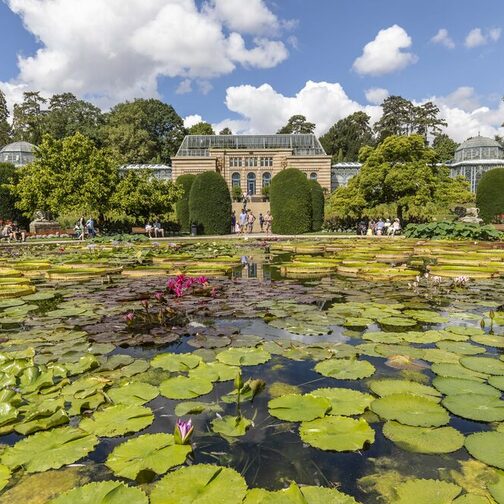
383,421,464,454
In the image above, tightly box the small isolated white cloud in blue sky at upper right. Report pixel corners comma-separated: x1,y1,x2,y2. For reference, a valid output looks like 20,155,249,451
353,25,418,75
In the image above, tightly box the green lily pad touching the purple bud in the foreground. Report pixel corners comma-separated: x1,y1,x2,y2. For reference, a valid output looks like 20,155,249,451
105,434,192,479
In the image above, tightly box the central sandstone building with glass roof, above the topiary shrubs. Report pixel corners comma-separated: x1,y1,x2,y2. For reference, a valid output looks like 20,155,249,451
172,134,331,197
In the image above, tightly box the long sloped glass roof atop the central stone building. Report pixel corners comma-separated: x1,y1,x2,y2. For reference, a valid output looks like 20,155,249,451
177,135,325,156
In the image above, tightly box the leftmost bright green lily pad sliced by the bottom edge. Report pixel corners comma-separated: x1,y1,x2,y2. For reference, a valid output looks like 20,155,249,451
48,481,149,504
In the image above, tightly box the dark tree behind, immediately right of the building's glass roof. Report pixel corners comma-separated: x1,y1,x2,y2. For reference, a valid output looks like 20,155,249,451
320,112,374,162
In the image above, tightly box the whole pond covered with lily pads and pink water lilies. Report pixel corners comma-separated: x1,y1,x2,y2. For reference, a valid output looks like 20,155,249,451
0,239,504,504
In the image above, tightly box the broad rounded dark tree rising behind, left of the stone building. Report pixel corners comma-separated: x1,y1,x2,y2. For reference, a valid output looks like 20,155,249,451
102,99,186,163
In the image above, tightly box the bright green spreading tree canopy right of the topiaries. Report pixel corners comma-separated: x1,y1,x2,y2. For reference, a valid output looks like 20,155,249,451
327,135,474,221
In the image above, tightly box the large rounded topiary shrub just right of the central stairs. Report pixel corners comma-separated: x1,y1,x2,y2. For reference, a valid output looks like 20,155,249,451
270,168,312,234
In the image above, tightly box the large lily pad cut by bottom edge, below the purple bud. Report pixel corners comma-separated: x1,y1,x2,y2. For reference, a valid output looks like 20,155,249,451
150,464,247,504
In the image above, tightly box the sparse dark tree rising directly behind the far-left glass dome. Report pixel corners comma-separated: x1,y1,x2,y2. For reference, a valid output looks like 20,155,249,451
12,91,47,145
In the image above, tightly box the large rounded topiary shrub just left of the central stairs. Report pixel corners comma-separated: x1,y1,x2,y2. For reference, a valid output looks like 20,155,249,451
189,171,231,235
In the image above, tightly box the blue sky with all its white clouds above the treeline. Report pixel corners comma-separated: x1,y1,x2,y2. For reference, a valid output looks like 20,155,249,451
0,0,504,140
